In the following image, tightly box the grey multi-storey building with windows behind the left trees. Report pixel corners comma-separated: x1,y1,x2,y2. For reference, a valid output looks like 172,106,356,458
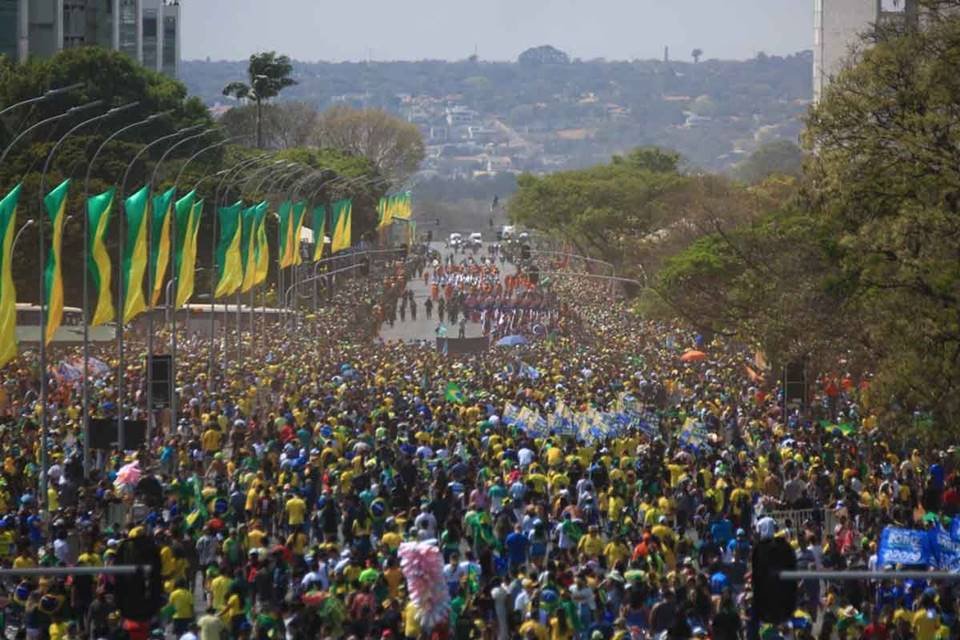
0,0,180,78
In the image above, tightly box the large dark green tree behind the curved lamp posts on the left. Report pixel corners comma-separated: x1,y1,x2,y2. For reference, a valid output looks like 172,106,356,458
0,47,212,306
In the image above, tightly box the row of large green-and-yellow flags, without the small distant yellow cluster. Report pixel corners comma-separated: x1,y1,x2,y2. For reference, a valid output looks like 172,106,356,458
0,179,353,367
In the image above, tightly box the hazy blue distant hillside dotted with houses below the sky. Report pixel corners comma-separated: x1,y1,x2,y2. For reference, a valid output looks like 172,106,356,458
182,48,812,172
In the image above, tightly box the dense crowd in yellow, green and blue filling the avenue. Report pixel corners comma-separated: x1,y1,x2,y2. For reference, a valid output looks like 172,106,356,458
0,246,960,640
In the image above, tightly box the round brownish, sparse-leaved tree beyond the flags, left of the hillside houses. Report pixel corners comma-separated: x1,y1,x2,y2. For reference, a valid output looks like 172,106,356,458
315,106,425,182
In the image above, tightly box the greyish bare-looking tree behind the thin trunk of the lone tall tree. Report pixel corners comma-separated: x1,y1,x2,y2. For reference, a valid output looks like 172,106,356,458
220,102,320,149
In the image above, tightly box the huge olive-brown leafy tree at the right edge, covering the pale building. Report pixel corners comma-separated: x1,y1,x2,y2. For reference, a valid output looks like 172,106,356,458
805,15,960,435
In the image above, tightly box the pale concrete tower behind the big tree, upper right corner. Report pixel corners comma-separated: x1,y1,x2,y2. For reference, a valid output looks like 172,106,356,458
813,0,918,101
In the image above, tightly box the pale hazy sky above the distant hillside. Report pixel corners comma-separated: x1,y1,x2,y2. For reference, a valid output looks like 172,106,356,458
181,0,813,61
